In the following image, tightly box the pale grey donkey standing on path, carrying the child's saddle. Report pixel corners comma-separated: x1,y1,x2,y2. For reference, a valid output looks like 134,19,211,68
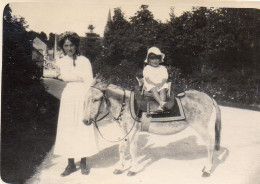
83,79,221,177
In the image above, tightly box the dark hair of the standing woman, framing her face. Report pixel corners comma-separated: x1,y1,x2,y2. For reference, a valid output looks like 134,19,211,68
58,31,80,55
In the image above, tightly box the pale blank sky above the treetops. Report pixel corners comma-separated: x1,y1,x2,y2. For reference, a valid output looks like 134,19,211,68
2,0,260,36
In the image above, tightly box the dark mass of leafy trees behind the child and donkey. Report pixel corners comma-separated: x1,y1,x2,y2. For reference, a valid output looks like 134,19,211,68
100,5,260,105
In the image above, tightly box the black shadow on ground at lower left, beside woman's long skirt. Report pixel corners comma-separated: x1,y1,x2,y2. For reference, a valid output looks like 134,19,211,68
1,86,59,184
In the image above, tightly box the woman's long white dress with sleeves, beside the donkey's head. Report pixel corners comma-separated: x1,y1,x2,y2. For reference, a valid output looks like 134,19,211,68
54,56,98,158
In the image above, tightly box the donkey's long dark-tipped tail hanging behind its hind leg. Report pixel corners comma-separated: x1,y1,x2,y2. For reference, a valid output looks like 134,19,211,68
212,99,221,150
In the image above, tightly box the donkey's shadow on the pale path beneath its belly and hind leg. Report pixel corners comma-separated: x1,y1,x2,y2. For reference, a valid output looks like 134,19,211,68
137,135,229,173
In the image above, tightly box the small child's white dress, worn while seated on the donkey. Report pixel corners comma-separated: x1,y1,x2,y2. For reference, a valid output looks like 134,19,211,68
143,65,169,91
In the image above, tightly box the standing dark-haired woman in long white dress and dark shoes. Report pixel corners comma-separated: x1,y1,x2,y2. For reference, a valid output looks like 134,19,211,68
54,32,98,176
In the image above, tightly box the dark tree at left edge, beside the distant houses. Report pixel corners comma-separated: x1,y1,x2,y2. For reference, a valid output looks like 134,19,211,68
2,4,41,89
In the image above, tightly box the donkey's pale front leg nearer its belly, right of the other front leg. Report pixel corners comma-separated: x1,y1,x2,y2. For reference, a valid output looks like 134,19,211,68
127,123,140,176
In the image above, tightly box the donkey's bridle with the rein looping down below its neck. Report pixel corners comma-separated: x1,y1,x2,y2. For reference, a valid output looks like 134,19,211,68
91,86,136,142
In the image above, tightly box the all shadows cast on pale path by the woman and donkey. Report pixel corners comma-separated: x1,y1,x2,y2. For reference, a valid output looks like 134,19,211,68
27,135,229,184
